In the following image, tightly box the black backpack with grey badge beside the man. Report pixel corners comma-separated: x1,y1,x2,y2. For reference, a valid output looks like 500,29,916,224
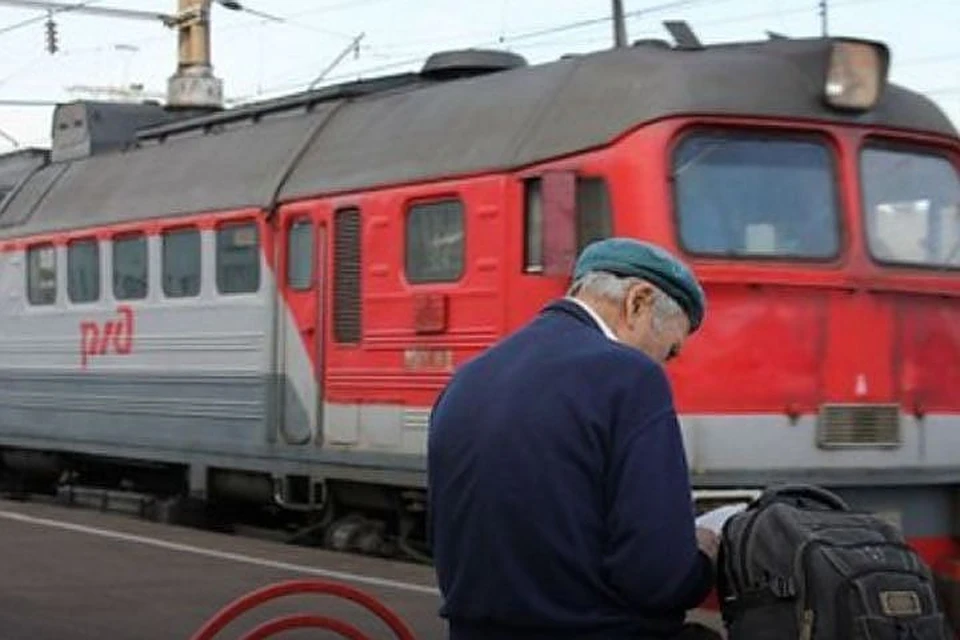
717,485,953,640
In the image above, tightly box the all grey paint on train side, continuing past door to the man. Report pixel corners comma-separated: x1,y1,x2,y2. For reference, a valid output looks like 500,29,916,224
0,231,426,487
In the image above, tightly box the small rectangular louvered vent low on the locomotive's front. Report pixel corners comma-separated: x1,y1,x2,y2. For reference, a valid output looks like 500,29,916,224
817,404,901,448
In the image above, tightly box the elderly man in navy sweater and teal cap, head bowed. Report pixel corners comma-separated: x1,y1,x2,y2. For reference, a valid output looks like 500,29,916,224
428,238,717,640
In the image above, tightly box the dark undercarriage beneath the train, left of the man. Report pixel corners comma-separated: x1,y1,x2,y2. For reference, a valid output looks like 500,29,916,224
0,448,430,563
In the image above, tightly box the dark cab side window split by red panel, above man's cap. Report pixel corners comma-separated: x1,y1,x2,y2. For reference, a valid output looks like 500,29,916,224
523,177,613,273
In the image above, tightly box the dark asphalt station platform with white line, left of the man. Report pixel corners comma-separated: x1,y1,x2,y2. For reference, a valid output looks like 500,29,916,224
0,500,446,640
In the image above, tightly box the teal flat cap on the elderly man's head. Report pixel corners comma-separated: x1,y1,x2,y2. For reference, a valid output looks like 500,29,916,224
573,238,707,333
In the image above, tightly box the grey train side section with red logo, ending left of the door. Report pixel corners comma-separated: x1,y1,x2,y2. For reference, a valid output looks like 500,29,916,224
0,240,278,460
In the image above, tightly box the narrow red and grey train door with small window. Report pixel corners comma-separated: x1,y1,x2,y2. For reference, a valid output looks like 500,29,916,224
277,212,327,446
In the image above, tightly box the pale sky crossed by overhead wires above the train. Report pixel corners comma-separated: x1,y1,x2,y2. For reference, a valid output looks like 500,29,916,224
0,0,960,153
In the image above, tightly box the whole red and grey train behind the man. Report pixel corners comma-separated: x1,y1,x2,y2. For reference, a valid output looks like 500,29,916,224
0,31,960,596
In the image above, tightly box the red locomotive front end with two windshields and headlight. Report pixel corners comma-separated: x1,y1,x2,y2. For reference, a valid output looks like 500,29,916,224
614,40,960,615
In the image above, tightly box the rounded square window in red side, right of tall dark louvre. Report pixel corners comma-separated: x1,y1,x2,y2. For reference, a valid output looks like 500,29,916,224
406,200,465,284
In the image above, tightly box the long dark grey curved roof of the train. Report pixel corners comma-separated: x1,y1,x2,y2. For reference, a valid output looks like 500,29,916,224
0,38,957,237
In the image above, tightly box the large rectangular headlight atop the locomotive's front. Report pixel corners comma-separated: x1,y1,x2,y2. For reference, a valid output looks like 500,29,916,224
824,40,890,111
